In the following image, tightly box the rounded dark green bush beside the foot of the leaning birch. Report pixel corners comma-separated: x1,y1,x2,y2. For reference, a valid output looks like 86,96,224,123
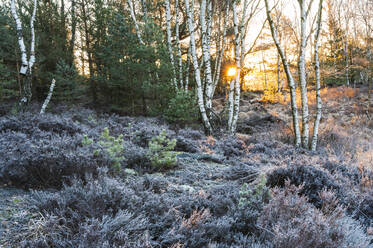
164,90,199,123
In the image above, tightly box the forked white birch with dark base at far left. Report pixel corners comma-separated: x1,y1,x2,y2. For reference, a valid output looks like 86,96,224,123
11,0,37,106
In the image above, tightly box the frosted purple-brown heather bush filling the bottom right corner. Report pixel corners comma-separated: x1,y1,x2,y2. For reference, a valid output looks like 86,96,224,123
257,181,368,248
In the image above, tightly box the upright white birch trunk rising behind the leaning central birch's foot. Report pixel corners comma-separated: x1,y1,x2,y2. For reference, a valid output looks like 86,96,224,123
200,0,213,118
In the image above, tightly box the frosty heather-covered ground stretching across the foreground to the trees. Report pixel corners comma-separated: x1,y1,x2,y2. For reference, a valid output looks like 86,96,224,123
0,87,373,248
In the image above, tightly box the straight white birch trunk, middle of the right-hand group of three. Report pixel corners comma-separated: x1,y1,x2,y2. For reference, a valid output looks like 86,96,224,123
298,0,309,148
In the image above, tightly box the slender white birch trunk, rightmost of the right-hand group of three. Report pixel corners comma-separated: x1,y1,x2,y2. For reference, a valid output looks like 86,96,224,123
311,0,323,151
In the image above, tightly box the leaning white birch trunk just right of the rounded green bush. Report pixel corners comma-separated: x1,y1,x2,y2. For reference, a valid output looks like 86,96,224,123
185,0,212,134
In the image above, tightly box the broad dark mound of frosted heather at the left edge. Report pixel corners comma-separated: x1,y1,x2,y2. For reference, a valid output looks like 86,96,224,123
0,132,110,188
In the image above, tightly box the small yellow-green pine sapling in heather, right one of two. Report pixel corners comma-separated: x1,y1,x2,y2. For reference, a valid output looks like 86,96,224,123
148,130,177,169
